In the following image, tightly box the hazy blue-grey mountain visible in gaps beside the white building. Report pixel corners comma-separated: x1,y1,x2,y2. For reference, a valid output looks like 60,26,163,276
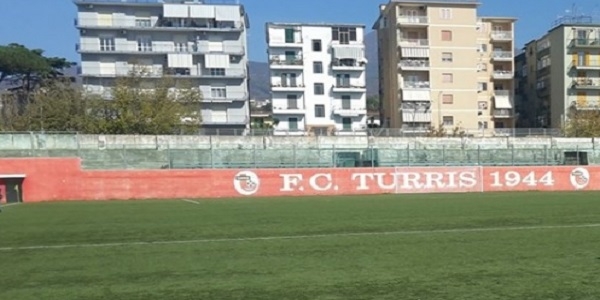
248,31,379,99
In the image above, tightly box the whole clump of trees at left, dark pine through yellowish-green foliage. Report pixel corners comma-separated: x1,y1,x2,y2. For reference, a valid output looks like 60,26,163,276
0,44,202,134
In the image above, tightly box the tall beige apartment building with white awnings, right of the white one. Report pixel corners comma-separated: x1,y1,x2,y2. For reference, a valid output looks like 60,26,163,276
373,0,515,132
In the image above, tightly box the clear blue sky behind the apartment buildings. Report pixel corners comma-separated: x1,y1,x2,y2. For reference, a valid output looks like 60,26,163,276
0,0,600,62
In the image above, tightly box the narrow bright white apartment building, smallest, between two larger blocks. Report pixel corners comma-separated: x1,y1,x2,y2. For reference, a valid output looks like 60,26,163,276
266,23,367,134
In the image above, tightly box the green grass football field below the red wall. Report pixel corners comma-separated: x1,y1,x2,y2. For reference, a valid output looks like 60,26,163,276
0,193,600,300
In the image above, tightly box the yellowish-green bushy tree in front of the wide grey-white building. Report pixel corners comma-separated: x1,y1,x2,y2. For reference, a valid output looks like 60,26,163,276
88,69,202,134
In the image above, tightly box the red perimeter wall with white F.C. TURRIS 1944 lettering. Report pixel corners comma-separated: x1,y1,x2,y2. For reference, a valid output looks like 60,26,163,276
0,158,600,202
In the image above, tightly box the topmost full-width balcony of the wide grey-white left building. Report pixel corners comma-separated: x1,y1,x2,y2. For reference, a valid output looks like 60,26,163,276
73,16,244,32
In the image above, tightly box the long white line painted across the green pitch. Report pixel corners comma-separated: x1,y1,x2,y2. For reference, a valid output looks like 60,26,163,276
0,224,600,252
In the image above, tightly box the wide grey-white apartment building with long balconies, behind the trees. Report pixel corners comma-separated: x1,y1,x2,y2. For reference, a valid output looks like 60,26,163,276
74,0,249,129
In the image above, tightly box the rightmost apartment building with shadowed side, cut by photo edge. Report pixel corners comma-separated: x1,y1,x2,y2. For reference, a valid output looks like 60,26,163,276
516,15,600,129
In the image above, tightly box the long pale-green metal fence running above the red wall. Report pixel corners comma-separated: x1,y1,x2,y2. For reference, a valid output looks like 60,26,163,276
0,144,600,169
